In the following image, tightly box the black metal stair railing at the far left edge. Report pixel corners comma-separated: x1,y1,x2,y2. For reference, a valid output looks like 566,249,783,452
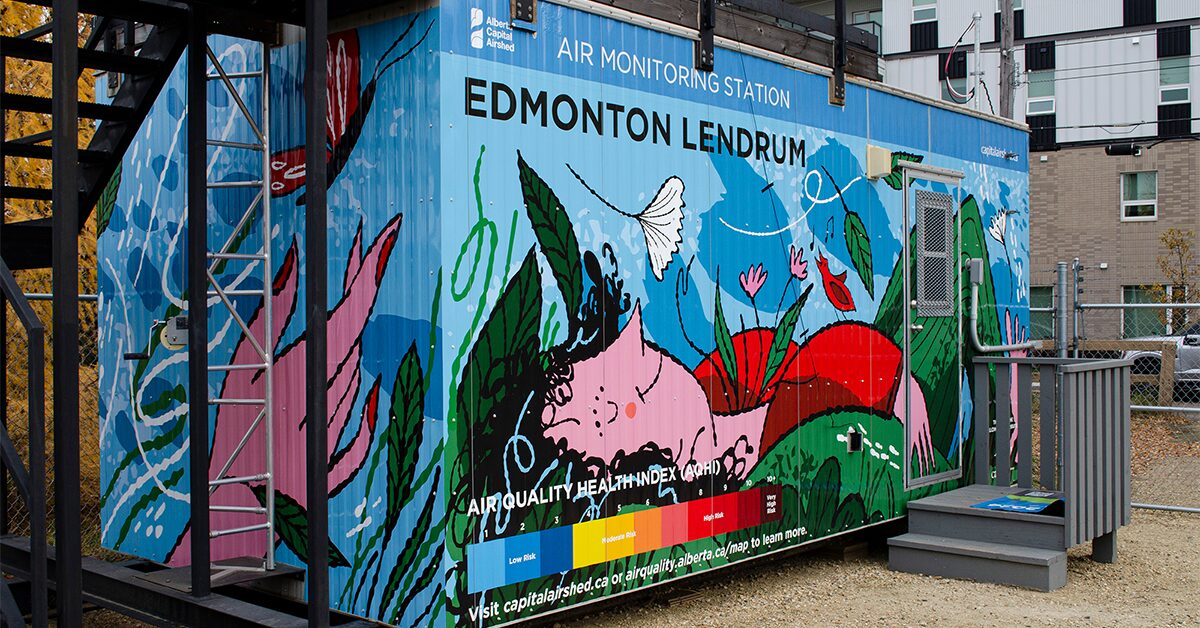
0,254,49,627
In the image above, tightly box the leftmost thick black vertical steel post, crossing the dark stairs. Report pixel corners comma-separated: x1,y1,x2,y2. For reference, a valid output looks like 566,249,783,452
50,0,83,626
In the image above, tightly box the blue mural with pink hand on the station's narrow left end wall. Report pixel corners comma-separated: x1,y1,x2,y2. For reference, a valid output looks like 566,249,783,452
100,12,444,623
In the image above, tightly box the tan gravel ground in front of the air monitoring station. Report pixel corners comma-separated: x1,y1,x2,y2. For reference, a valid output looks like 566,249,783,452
572,510,1200,627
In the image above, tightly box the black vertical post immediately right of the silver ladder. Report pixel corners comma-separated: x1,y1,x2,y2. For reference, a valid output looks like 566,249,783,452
305,0,329,628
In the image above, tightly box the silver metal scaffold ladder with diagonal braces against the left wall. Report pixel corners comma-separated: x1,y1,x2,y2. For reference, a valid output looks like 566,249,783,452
208,46,275,570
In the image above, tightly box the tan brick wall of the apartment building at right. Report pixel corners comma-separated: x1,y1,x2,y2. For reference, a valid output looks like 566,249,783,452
1030,140,1200,339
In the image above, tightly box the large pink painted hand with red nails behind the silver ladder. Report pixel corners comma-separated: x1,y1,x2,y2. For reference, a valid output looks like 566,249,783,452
168,215,401,564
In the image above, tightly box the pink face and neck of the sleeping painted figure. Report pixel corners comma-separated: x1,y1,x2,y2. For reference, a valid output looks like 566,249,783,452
541,305,767,479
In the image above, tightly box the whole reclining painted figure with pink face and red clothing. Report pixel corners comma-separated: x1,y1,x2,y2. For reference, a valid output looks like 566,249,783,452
541,306,934,478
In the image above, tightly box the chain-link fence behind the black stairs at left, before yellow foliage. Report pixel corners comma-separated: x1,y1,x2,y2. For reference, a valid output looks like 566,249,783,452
4,294,102,556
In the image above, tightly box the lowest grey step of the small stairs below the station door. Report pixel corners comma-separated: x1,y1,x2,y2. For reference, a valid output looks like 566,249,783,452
888,532,1067,591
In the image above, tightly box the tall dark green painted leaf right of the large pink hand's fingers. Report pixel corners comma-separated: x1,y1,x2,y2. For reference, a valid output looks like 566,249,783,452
383,342,425,530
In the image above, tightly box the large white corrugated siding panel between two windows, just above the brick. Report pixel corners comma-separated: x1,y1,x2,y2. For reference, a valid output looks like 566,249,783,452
1051,32,1158,142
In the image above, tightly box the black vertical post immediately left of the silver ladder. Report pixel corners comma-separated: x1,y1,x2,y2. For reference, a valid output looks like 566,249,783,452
187,7,212,605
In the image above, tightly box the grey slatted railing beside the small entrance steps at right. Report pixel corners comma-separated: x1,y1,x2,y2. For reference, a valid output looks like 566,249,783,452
974,357,1133,546
